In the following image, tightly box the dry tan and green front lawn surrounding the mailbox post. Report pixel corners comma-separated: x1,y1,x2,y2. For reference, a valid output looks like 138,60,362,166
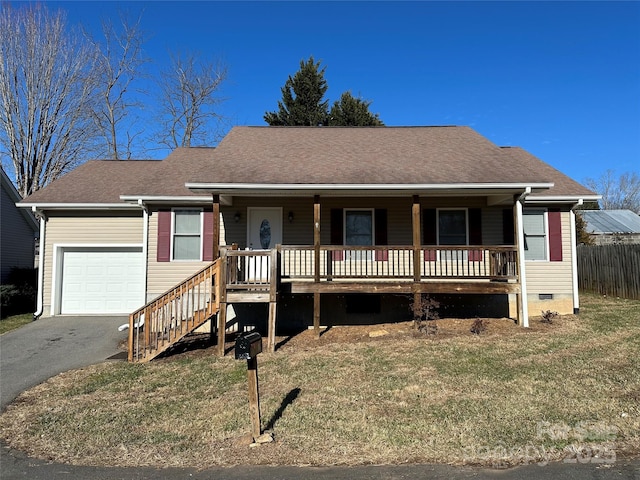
0,296,640,468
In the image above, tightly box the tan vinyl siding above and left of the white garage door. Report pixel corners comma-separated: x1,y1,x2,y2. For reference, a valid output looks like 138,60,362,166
41,211,143,315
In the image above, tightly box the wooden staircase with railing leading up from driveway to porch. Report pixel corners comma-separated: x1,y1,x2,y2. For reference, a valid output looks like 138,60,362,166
128,259,224,362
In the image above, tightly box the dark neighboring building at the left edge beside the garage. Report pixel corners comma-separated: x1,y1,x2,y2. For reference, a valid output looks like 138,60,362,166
0,169,38,283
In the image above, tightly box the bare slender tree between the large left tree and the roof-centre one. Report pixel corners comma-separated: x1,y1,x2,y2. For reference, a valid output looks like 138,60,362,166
90,14,148,160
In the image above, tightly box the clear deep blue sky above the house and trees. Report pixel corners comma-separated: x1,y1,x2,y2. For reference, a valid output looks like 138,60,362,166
47,1,640,185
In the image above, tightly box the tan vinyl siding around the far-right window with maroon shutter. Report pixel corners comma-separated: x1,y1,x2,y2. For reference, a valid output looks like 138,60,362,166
525,212,573,296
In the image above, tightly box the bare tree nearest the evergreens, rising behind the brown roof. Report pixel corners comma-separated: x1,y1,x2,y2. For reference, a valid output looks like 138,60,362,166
159,54,227,148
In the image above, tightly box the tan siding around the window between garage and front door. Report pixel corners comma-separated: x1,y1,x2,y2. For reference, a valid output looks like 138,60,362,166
147,210,226,301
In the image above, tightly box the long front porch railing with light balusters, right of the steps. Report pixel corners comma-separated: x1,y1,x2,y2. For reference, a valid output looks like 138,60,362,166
279,245,517,280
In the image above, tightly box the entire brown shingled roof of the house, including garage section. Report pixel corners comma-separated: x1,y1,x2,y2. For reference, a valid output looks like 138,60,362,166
23,126,594,204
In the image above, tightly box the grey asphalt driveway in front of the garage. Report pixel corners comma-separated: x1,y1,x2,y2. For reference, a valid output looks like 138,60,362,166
0,316,128,411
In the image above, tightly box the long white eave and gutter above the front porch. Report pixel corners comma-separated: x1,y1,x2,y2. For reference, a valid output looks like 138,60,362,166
185,182,553,197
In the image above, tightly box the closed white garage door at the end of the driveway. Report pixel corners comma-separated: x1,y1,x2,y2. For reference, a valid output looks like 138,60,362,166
60,248,144,314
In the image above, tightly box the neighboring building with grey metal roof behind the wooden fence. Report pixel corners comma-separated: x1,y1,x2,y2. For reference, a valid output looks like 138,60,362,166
580,210,640,245
